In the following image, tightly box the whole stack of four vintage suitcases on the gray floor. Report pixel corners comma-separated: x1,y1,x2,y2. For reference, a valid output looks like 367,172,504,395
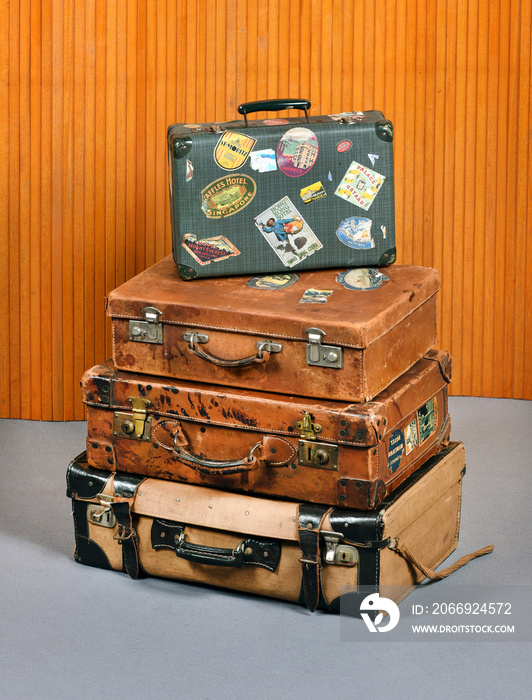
67,100,491,610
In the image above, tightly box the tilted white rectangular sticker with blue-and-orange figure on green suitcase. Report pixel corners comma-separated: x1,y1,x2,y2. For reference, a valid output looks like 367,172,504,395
255,197,323,267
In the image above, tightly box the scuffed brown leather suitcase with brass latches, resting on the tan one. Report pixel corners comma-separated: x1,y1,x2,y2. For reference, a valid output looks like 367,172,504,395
82,350,451,509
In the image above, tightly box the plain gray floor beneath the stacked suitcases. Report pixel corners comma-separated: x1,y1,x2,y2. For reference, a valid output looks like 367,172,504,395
0,398,532,700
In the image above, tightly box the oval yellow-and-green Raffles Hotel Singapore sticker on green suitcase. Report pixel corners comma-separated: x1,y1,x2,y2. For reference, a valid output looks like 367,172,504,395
201,173,257,219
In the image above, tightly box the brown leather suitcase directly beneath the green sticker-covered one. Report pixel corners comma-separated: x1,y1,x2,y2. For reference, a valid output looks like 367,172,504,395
107,256,439,401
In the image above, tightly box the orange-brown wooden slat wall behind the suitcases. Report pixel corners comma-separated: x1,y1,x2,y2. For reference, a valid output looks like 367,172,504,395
0,0,532,420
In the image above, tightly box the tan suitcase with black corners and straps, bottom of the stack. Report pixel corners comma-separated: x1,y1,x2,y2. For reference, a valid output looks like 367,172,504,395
67,443,492,610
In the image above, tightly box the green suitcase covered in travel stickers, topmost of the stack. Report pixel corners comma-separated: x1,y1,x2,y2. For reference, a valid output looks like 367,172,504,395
168,100,395,279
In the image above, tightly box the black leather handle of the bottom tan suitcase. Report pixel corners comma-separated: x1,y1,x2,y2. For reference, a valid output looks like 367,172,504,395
151,518,281,571
